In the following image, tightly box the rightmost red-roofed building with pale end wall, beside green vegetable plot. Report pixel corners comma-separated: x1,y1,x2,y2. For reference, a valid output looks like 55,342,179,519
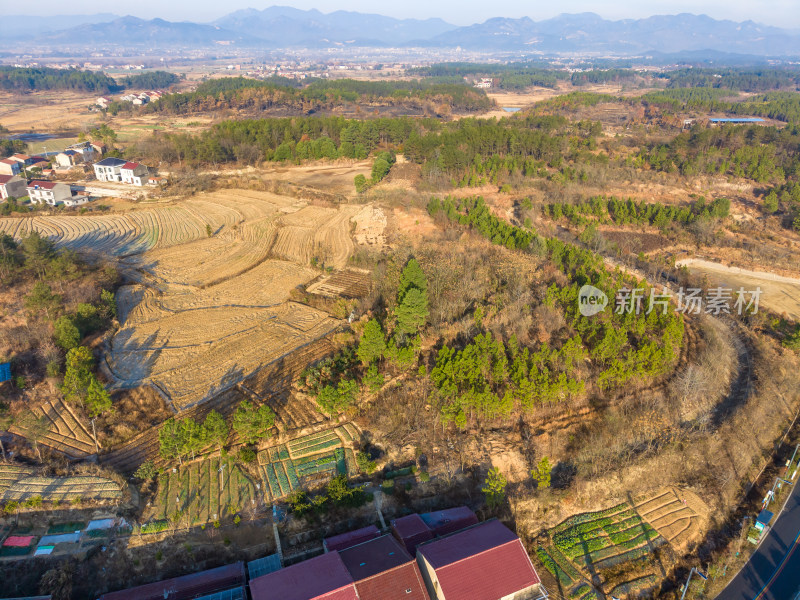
417,520,547,600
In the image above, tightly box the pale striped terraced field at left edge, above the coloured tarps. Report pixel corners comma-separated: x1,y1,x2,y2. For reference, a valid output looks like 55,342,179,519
0,465,122,502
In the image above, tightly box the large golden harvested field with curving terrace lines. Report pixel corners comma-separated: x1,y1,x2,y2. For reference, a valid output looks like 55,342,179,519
0,189,386,412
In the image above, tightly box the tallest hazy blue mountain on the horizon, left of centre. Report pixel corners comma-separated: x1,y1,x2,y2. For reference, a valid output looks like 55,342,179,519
214,6,457,47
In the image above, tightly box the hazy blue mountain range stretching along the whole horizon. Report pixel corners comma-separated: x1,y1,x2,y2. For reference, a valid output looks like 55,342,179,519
6,6,800,56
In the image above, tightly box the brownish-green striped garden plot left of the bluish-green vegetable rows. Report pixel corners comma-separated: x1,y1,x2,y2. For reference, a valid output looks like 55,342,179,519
149,457,257,525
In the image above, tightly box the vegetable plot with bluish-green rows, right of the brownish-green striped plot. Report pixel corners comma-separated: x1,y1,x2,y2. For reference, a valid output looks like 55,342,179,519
258,423,360,500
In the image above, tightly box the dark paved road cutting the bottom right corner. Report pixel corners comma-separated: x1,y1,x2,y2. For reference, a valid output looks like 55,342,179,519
717,483,800,600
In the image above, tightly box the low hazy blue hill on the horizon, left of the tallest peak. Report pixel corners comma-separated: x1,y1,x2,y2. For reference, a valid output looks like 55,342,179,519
35,16,259,48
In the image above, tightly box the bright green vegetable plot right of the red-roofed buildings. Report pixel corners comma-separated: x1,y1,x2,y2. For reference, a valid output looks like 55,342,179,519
537,502,668,600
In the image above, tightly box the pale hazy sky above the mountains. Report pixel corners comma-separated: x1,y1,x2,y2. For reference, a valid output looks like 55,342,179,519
15,0,800,29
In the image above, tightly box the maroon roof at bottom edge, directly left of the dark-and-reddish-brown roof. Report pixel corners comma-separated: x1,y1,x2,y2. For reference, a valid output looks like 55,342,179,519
250,552,359,600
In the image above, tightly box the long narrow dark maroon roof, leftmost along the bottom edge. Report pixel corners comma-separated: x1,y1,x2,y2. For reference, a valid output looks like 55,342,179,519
95,562,245,600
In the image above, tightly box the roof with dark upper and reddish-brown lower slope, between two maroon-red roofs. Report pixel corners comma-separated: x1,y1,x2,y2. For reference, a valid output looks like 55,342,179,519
339,535,430,600
